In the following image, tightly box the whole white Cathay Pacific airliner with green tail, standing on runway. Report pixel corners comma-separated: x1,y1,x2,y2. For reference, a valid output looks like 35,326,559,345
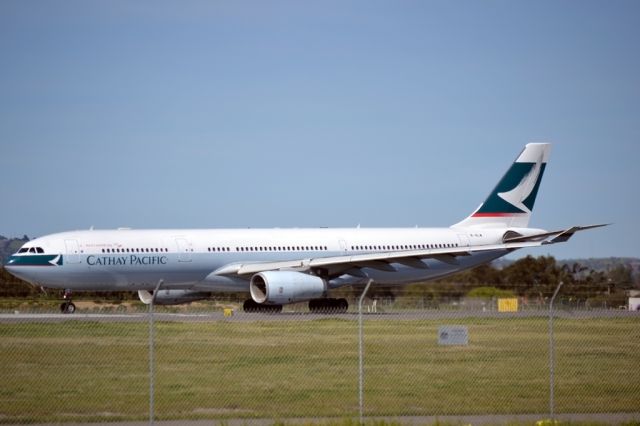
5,143,606,313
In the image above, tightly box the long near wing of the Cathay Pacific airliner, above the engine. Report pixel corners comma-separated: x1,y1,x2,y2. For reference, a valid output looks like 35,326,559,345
212,224,606,276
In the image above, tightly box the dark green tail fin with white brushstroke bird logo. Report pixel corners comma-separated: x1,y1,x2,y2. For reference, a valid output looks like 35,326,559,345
453,143,551,228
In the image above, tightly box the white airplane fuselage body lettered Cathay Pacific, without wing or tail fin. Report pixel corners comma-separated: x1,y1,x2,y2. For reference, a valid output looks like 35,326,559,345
6,228,516,291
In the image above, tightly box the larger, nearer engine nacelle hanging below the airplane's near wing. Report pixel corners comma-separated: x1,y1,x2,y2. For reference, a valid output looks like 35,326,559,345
249,271,327,305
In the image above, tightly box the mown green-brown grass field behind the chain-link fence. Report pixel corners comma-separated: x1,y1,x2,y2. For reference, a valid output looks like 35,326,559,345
0,317,640,423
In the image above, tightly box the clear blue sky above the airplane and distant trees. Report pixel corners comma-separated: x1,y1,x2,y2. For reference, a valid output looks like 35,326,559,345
0,0,640,258
